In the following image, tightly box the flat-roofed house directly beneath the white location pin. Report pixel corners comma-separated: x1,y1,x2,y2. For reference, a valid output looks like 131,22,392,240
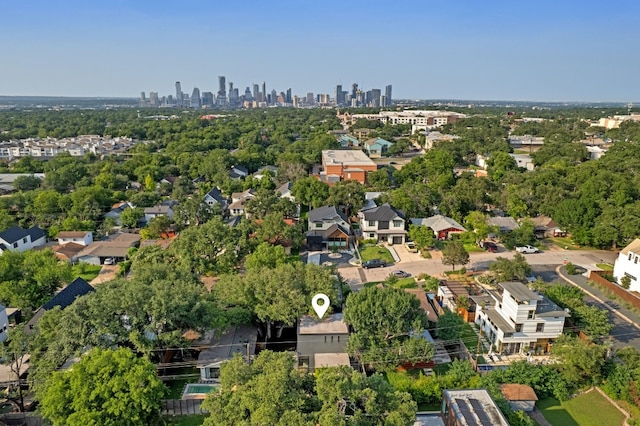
296,314,350,372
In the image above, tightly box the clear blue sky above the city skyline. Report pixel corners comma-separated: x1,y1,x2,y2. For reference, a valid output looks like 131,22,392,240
0,0,640,102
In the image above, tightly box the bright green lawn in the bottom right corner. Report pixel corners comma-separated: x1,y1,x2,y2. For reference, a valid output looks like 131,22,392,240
536,390,624,426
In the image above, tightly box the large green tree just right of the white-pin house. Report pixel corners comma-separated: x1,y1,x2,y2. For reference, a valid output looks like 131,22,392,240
344,287,434,370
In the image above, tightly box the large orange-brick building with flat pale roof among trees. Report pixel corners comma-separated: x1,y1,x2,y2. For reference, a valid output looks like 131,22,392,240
320,150,378,183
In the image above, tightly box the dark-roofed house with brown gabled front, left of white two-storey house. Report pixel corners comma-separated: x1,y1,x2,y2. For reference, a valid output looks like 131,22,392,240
306,206,352,251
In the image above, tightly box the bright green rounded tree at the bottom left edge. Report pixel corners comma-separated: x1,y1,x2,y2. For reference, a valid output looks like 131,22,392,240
40,348,167,426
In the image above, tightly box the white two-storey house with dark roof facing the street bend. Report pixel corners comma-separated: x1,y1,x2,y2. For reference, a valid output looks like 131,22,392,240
358,203,407,244
